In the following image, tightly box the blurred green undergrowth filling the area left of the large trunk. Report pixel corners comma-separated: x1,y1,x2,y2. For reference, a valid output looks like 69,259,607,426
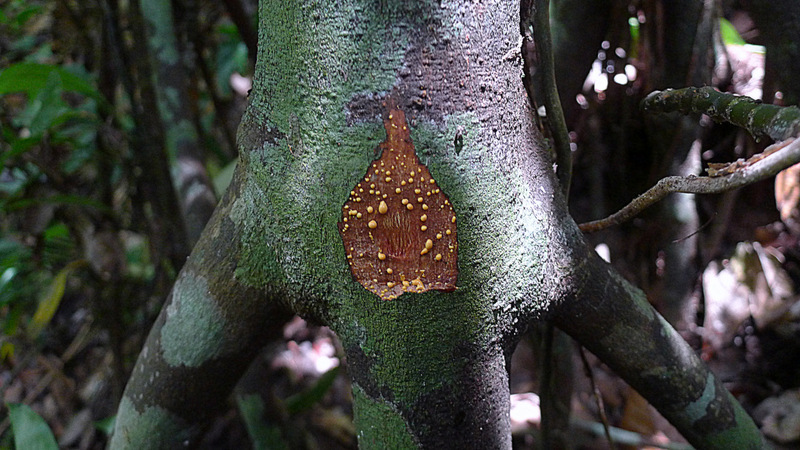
0,0,253,448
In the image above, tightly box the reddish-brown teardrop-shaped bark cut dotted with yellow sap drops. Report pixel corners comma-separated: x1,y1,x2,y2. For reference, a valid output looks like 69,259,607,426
339,106,458,300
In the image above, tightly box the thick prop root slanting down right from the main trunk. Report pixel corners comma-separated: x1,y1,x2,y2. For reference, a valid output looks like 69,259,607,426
553,252,763,449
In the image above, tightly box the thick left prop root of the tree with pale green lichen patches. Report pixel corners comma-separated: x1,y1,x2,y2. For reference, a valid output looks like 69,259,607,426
110,167,291,449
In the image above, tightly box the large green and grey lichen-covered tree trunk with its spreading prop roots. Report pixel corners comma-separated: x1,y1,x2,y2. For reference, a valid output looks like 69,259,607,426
111,0,760,448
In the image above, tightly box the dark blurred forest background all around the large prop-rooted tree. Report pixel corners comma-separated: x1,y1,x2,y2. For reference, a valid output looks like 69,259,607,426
0,0,800,448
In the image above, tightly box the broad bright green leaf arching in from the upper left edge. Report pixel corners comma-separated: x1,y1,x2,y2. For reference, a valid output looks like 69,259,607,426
0,62,103,101
